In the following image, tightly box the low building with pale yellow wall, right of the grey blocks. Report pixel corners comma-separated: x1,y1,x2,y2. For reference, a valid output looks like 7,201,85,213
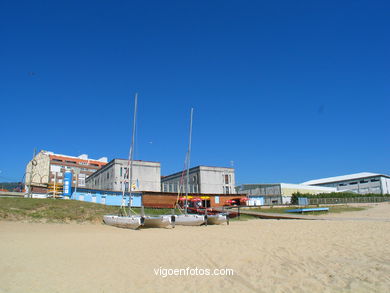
237,183,337,206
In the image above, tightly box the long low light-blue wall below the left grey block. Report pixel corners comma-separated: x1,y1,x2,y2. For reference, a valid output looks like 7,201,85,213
70,188,142,207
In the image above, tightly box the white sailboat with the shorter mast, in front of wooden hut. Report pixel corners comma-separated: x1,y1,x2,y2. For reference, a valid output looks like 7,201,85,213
174,108,206,226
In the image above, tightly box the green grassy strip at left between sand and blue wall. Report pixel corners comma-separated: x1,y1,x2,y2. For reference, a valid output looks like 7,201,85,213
0,198,171,223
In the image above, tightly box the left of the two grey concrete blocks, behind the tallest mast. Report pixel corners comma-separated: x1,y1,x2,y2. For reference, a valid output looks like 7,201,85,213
86,159,161,192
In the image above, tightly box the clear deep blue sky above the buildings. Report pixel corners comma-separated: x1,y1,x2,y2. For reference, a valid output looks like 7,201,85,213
0,0,390,184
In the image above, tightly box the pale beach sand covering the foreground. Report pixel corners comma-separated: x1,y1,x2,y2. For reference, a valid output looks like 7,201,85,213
0,203,390,293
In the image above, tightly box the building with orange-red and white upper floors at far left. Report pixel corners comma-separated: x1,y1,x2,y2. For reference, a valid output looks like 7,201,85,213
25,150,107,193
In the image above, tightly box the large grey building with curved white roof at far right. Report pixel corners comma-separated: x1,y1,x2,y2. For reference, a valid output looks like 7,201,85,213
302,172,390,194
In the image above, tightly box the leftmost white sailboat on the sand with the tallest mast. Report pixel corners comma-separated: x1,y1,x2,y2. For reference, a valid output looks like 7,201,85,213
103,93,145,229
